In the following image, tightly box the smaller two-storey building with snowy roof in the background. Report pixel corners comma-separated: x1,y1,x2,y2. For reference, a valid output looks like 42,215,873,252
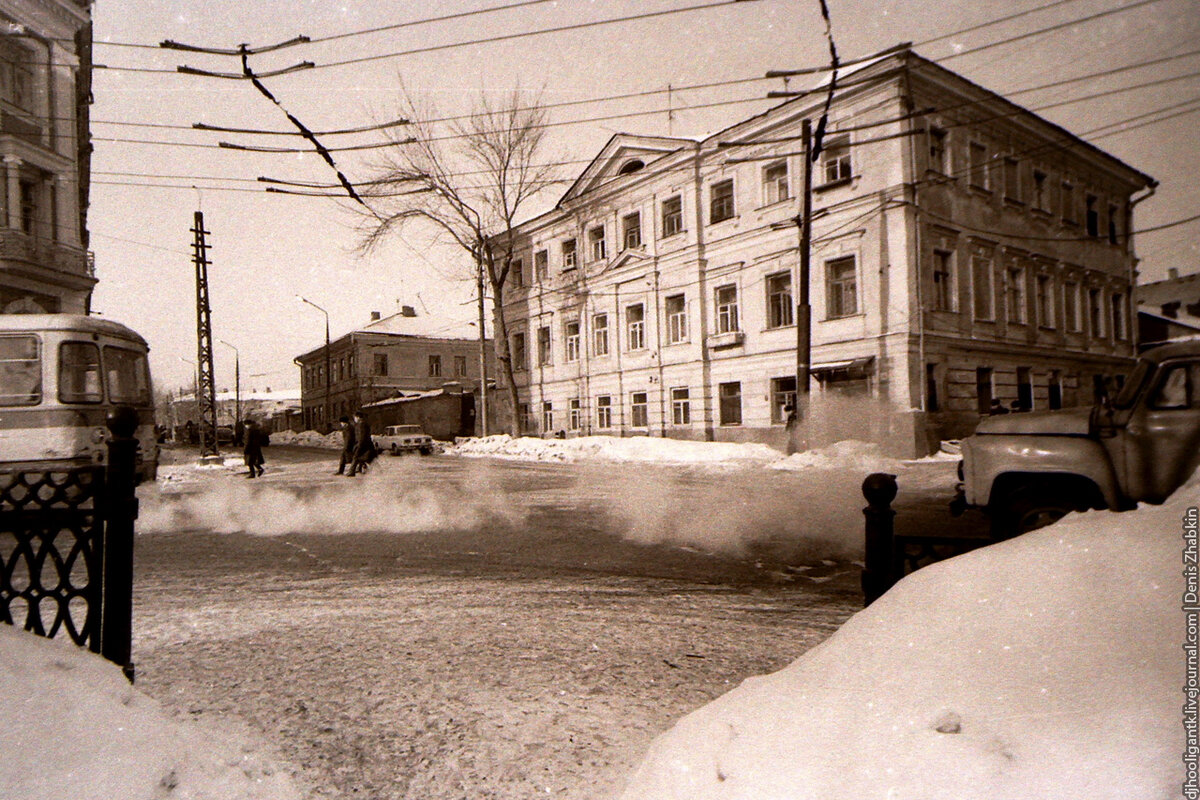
295,306,496,432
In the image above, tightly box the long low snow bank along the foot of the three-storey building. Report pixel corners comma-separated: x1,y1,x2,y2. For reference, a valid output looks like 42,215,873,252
446,434,781,465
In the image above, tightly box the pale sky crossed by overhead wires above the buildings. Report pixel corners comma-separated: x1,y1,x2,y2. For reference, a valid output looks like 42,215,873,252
89,0,1200,390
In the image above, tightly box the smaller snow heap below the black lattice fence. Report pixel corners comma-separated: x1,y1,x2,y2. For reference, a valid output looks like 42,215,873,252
0,624,304,800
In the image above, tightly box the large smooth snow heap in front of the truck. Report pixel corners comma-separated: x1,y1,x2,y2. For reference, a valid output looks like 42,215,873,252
624,477,1200,800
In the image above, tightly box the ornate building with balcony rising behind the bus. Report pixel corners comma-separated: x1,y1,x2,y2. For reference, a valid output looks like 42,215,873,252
0,0,96,313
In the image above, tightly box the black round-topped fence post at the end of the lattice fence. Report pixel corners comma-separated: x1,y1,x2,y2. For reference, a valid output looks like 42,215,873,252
100,405,138,684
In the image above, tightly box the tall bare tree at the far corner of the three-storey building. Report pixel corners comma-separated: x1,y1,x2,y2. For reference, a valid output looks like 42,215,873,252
360,90,560,435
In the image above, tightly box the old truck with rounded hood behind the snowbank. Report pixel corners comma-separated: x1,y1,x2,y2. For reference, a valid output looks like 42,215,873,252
950,339,1200,539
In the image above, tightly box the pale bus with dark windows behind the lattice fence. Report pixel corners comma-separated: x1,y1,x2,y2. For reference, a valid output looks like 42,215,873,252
0,314,158,481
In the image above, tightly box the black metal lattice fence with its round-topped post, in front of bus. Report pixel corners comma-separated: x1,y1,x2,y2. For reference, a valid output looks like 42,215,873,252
0,409,137,681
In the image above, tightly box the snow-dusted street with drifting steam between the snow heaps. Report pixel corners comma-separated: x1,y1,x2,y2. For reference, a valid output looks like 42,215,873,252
134,447,974,798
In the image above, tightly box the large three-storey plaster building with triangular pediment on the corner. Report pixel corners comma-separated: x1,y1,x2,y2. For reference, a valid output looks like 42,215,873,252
492,50,1153,453
